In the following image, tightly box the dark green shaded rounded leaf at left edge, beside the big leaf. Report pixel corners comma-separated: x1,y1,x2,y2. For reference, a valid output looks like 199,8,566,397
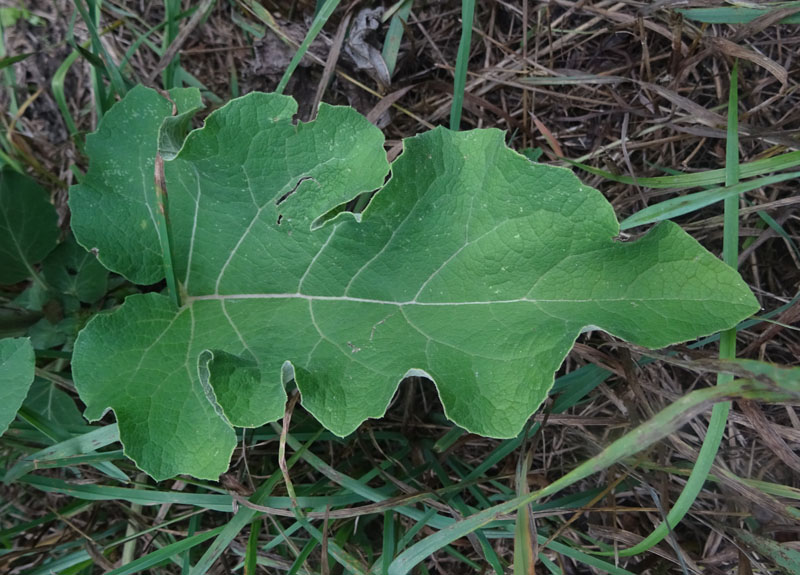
0,166,58,284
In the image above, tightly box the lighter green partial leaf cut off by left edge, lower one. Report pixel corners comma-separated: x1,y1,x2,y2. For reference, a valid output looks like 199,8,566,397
0,337,36,435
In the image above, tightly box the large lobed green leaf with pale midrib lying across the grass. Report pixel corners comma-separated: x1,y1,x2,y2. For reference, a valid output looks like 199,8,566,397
72,88,758,478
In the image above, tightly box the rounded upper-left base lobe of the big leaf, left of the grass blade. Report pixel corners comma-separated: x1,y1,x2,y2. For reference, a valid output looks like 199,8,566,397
69,86,201,284
